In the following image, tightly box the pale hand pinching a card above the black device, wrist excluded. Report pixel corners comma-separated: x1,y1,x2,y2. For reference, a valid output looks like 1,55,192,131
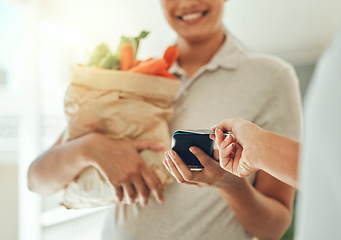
210,119,263,177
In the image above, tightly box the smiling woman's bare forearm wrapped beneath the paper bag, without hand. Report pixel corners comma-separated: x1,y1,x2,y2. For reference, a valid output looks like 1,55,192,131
28,135,90,195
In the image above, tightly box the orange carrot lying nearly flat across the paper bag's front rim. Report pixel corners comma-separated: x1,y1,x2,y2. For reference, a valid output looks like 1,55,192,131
129,58,167,75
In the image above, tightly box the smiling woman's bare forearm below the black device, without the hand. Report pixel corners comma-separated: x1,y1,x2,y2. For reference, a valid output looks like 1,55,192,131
217,179,291,239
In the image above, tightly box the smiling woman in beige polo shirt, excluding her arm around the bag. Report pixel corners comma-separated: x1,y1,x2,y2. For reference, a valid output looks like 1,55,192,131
99,0,300,240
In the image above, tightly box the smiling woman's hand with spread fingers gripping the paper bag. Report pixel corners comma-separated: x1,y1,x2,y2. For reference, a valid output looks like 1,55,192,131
84,133,164,206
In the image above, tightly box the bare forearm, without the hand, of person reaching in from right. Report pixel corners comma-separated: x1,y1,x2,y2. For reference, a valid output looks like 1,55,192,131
255,131,300,188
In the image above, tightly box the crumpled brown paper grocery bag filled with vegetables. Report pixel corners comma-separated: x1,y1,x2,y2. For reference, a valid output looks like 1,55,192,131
62,65,180,208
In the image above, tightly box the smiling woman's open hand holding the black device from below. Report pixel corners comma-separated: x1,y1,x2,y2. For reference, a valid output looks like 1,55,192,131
163,147,239,188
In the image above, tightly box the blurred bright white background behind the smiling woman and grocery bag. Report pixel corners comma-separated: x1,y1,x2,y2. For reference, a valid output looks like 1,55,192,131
0,0,341,240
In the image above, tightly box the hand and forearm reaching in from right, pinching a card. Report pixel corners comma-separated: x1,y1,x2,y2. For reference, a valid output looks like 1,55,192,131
213,118,300,188
